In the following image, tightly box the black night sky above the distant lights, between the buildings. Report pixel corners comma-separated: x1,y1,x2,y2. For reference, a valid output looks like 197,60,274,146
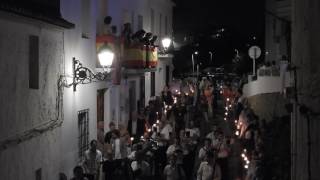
173,0,265,75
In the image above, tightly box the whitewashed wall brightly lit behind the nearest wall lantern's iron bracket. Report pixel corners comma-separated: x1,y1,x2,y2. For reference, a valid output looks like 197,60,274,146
61,0,114,177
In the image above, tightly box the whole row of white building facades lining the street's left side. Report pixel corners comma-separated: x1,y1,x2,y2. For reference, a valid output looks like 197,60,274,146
0,0,173,180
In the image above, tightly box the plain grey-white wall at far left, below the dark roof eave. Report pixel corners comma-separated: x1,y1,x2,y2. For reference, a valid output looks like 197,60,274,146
0,12,63,180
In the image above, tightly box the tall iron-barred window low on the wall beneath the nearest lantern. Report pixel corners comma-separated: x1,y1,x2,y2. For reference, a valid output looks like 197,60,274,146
78,109,89,160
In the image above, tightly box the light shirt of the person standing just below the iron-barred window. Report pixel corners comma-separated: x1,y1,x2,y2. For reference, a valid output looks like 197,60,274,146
83,149,102,174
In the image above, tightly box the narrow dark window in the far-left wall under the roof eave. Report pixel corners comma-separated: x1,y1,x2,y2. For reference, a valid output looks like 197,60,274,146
29,35,39,89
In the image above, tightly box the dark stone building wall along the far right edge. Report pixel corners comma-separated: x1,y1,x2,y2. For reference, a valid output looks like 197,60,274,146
292,0,320,180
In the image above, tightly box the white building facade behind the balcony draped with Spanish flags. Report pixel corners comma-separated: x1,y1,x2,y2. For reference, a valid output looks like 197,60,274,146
98,0,174,130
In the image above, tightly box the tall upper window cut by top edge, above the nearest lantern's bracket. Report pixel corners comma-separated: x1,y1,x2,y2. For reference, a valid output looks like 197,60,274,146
81,0,91,38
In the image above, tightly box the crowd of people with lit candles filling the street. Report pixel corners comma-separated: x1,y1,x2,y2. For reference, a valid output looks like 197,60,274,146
69,78,272,180
